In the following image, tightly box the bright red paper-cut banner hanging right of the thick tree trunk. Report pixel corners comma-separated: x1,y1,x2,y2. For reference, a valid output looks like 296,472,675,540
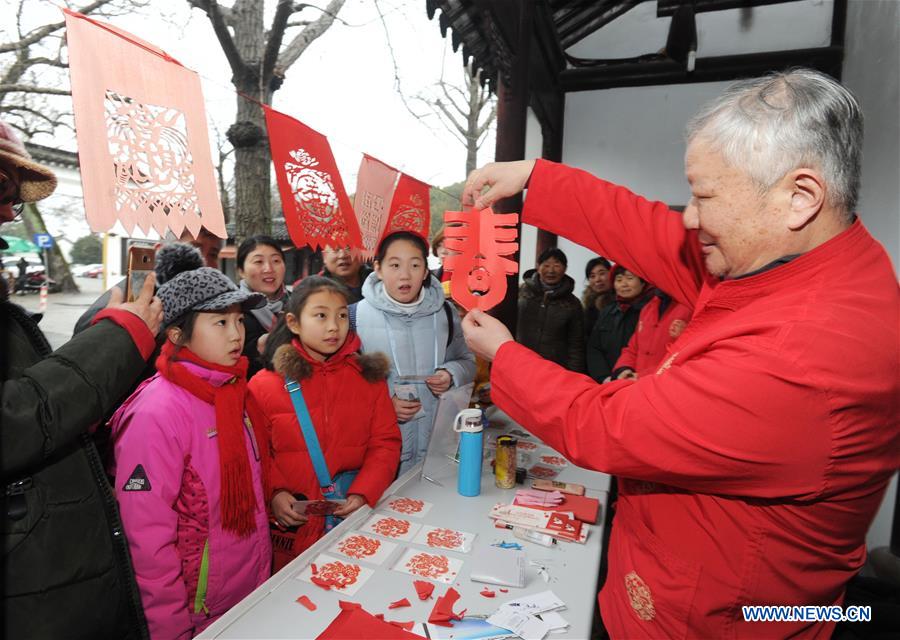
264,107,362,250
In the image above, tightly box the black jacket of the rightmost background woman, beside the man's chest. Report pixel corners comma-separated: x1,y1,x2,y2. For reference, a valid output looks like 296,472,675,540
587,287,653,382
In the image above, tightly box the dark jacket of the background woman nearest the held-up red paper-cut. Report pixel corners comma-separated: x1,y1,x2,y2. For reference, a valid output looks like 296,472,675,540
516,269,584,371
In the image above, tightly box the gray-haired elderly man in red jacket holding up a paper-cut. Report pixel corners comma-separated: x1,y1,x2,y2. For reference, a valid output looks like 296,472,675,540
463,70,900,638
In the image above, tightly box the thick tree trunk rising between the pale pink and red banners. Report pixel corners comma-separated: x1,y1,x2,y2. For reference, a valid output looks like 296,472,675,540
227,0,272,243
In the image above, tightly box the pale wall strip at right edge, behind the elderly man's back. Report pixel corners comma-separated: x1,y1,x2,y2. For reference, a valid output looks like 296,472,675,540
843,0,900,548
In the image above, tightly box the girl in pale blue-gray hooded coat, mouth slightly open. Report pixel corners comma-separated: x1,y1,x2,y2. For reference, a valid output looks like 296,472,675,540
355,231,475,474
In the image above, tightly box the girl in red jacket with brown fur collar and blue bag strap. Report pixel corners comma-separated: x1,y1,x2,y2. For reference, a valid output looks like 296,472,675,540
249,276,400,570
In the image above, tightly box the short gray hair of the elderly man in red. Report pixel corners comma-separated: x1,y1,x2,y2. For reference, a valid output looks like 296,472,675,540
687,69,863,217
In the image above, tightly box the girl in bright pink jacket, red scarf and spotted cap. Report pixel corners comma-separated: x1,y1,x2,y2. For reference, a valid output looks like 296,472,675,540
110,267,271,640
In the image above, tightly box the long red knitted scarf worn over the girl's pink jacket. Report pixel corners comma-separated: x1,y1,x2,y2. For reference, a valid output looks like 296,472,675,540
156,340,268,538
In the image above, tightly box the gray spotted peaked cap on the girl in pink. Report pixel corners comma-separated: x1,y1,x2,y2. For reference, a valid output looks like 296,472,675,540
156,267,266,327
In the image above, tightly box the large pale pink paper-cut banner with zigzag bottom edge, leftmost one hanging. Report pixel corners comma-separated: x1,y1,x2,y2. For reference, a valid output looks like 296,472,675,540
64,10,225,238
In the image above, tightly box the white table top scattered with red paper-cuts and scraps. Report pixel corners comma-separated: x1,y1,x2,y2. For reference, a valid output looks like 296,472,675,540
198,412,609,638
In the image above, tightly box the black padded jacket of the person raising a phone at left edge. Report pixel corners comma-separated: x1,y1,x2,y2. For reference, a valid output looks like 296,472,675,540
0,282,148,640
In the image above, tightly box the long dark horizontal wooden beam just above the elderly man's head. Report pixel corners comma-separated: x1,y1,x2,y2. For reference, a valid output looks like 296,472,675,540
559,47,844,92
